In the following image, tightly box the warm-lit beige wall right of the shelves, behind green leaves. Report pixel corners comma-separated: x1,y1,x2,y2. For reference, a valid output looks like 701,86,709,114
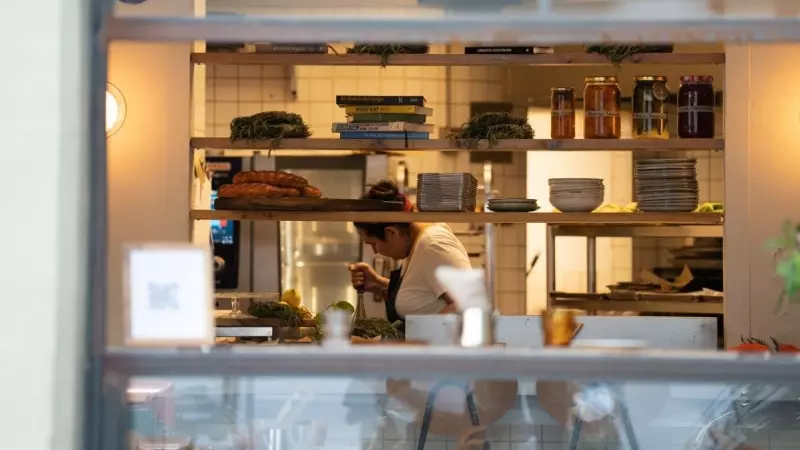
724,44,800,344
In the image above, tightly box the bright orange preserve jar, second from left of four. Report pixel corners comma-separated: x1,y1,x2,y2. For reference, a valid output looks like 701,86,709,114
583,77,622,139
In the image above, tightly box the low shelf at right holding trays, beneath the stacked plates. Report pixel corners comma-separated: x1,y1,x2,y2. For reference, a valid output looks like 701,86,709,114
550,292,723,314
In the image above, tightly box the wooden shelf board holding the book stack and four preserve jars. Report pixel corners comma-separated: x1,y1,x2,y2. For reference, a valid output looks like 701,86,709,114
190,137,725,152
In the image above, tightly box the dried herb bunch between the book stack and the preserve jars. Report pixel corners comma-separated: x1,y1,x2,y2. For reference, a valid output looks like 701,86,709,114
450,112,534,147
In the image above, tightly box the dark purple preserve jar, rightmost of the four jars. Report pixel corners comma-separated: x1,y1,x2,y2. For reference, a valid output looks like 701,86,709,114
678,75,714,139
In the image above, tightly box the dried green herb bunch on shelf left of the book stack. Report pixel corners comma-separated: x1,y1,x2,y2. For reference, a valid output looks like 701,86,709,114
231,111,311,147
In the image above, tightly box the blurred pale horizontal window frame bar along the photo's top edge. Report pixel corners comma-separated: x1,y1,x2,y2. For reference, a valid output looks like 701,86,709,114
110,0,800,44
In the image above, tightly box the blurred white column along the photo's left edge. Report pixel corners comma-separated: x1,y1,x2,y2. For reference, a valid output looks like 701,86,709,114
0,0,90,450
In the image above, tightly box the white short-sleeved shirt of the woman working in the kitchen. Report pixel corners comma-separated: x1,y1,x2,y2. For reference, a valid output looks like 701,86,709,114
395,224,472,317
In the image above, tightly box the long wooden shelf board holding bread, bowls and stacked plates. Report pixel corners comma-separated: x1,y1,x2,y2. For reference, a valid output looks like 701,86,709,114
191,210,723,227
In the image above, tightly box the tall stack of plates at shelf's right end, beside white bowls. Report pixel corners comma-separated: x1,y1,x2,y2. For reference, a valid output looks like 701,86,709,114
634,158,699,212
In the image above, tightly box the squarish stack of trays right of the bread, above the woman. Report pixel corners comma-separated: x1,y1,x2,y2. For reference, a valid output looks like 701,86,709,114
417,173,478,211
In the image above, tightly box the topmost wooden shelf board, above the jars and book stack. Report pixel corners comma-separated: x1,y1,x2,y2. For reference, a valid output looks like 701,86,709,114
191,53,725,66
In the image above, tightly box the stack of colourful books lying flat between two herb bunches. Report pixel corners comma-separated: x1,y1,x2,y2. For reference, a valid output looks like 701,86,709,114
332,95,433,139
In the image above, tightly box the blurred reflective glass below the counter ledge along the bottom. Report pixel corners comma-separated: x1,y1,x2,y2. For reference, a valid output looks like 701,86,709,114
127,376,800,450
